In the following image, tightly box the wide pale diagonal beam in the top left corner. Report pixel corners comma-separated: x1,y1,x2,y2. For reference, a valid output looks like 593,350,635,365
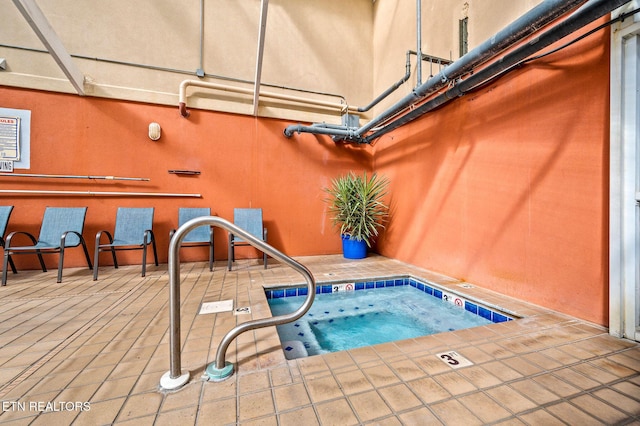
13,0,84,96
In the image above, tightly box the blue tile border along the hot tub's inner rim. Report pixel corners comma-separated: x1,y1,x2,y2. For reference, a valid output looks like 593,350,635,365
265,277,516,323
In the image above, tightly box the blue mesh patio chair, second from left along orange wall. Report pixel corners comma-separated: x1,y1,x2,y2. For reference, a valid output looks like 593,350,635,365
2,207,92,286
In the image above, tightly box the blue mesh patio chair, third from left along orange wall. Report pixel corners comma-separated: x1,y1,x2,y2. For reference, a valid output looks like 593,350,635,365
93,207,158,281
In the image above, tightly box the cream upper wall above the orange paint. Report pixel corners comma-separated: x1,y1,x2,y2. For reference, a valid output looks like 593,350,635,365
0,0,540,122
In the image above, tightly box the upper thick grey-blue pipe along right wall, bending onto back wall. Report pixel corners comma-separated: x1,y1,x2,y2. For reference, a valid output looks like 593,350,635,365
284,0,600,143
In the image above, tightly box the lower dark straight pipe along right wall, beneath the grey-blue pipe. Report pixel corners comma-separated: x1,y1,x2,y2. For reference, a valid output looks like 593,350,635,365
364,0,630,143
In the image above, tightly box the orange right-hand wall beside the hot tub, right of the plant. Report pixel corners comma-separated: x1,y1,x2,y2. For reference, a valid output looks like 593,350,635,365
375,21,609,324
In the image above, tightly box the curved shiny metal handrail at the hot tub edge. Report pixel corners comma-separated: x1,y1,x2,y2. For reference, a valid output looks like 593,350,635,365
160,216,316,389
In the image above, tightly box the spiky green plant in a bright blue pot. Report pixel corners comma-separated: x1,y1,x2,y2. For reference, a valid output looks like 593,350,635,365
325,172,389,259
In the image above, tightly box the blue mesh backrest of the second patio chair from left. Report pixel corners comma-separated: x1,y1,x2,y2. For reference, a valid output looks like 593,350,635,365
38,207,87,247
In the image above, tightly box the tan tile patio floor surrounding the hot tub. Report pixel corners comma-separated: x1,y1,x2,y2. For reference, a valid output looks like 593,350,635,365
0,256,640,426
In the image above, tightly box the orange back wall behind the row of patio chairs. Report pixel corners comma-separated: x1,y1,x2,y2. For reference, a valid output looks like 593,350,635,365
0,87,371,270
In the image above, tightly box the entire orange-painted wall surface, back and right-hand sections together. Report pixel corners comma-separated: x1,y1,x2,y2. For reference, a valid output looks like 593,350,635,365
0,20,609,324
